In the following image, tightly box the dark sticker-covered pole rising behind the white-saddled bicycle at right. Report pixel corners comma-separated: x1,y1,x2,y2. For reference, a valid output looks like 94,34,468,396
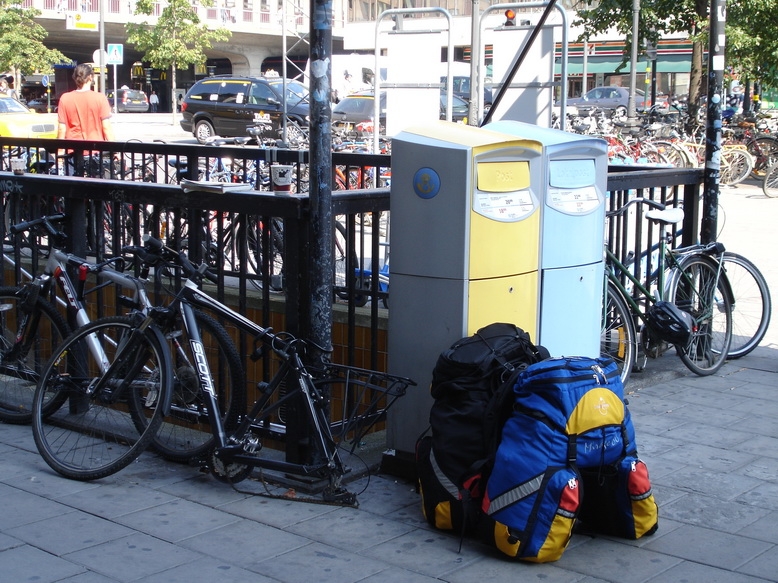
700,0,727,243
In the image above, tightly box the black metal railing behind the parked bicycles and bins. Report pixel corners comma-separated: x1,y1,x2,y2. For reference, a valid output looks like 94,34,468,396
0,138,702,370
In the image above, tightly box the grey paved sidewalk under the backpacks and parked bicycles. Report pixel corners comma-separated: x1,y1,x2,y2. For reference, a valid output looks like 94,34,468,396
0,348,778,583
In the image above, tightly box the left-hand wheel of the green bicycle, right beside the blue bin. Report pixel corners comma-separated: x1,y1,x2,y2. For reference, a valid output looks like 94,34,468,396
600,282,637,385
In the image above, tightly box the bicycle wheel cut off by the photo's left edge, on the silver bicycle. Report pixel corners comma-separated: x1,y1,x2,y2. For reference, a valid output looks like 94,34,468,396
0,287,69,424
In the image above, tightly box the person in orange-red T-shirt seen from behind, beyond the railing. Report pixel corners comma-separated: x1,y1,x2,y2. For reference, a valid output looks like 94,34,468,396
57,63,115,176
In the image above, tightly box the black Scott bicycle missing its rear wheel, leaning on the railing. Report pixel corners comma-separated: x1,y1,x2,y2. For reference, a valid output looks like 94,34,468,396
33,237,415,505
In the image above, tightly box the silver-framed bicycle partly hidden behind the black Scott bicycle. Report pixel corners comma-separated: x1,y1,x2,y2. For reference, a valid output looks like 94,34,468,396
0,214,245,461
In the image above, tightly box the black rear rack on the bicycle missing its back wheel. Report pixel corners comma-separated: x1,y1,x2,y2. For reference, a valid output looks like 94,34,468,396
314,364,416,453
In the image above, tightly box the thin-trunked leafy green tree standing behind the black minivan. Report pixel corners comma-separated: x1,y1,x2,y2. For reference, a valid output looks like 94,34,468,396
125,0,232,123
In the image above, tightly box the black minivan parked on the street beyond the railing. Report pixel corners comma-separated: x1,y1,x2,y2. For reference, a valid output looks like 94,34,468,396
181,75,310,144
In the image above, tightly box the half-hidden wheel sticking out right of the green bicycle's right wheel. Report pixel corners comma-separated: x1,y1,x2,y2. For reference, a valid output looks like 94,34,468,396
724,251,773,358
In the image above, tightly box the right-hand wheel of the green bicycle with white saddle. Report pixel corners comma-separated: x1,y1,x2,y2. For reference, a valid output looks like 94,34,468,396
668,255,732,376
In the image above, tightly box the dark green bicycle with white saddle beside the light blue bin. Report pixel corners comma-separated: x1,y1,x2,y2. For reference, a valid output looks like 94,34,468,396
600,198,732,383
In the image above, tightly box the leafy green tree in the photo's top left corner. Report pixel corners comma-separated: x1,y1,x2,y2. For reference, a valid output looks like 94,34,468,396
0,0,70,88
